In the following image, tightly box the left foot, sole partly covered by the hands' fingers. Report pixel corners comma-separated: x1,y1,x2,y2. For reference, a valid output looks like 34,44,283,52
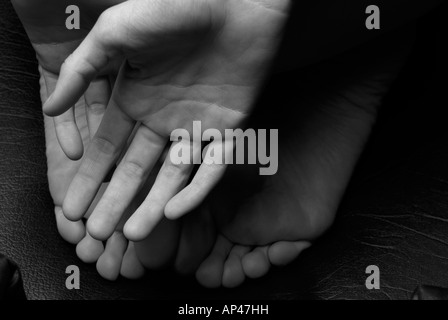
41,69,178,280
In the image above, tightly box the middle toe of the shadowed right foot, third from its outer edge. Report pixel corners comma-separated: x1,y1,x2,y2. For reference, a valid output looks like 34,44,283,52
222,246,250,288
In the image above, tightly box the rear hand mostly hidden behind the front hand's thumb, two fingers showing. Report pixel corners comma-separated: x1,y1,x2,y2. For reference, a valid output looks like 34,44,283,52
12,0,123,160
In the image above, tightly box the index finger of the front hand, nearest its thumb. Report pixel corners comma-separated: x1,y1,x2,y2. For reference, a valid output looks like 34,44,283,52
63,99,135,220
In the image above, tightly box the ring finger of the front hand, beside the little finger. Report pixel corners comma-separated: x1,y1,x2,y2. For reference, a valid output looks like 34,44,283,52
124,140,201,241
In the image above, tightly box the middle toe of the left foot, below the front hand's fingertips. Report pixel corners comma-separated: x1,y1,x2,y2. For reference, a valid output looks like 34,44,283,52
96,231,128,281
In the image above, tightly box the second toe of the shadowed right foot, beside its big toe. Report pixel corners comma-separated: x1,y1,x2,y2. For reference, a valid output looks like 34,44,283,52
196,236,233,288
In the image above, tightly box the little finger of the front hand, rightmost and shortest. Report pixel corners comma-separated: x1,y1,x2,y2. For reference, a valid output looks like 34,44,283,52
165,141,229,219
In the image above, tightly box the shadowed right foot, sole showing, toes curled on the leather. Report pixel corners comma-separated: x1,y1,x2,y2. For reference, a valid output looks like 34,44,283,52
183,31,408,288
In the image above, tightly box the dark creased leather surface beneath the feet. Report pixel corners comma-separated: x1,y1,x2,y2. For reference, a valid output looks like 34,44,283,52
0,0,448,299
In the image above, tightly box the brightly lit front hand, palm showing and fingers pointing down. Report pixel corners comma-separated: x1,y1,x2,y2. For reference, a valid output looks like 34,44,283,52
44,0,289,241
